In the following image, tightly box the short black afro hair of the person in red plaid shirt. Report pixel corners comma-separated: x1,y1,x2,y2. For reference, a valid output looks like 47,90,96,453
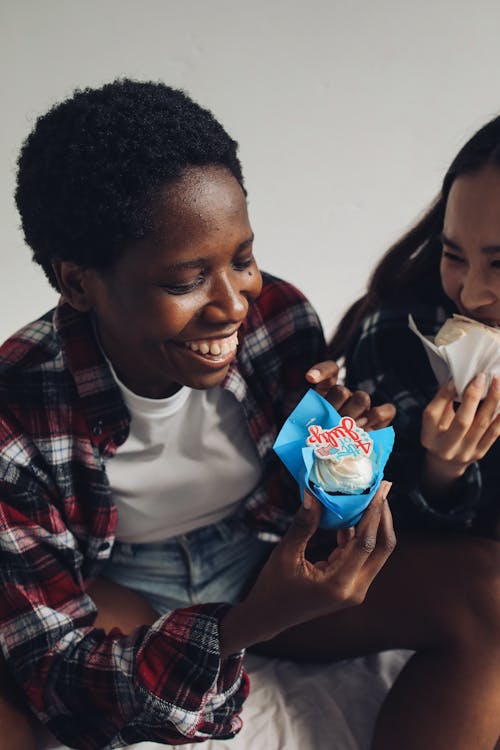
15,78,244,289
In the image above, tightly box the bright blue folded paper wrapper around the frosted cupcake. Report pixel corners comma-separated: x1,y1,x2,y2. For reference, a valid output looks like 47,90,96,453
273,389,394,529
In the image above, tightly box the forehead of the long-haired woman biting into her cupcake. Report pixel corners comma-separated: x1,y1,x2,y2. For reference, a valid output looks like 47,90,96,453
444,166,500,245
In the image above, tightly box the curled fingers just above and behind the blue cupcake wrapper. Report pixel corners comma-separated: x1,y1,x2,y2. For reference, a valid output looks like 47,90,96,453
306,360,396,432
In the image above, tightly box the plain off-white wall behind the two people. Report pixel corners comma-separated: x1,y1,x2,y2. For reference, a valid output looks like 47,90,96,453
0,0,500,340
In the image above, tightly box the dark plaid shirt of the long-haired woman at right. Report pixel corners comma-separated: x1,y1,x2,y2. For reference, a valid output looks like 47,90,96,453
345,292,500,535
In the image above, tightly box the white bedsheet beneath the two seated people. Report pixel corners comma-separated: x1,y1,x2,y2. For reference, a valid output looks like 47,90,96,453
47,651,411,750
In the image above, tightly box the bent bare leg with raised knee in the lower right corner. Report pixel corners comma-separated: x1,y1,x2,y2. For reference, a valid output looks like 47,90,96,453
254,536,500,750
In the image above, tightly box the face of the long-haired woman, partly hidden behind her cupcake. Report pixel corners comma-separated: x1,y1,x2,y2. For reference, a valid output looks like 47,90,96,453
440,166,500,326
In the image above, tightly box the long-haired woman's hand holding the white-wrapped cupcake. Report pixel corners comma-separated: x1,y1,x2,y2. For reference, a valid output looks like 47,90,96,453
420,373,500,492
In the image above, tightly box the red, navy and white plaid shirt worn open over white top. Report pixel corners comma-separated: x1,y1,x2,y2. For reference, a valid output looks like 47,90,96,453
0,275,325,749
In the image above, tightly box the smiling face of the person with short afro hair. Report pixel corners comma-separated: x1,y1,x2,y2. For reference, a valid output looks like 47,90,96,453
58,167,262,398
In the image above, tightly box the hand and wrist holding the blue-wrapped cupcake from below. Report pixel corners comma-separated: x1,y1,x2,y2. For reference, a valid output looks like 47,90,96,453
221,482,396,656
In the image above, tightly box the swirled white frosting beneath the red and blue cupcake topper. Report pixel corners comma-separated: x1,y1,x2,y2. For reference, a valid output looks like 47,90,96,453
310,454,373,495
